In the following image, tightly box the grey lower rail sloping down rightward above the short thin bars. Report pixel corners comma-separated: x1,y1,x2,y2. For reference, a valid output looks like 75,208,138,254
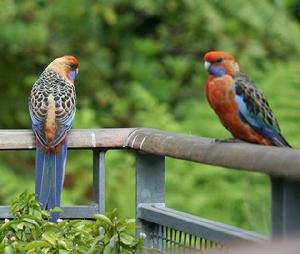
137,204,268,244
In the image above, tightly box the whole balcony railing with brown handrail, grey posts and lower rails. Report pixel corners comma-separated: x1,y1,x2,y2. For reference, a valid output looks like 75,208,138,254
0,128,300,253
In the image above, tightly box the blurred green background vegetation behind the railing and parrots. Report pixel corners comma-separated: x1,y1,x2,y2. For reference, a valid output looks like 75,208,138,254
0,0,300,233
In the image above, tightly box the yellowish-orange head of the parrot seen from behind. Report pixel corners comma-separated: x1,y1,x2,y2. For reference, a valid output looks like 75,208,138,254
47,56,79,82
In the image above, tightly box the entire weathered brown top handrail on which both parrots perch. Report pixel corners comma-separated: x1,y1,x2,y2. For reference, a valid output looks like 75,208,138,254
0,128,300,179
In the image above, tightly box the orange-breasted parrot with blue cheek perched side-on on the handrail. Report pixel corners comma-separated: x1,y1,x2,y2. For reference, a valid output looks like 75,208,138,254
204,51,290,147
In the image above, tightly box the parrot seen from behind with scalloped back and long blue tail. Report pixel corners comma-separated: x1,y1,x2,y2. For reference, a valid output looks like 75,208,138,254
29,56,78,222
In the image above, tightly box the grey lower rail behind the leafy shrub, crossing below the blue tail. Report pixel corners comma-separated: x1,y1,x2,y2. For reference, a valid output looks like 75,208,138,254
0,205,99,219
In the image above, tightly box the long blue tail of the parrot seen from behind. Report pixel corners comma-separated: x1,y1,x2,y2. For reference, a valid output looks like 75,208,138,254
35,144,67,222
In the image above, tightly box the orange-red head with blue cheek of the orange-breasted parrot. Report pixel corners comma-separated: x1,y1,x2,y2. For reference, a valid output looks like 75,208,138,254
204,51,240,77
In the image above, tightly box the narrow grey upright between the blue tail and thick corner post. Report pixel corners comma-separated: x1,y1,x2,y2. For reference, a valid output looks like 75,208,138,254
93,149,106,213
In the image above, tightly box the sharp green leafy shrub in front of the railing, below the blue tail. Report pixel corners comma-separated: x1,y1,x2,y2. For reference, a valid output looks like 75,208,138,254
0,192,143,254
